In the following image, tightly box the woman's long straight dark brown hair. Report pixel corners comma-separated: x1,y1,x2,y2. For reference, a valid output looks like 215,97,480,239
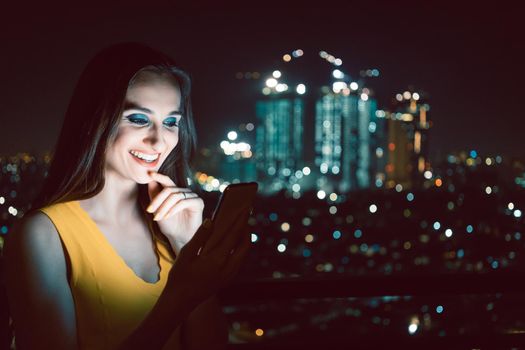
32,43,196,260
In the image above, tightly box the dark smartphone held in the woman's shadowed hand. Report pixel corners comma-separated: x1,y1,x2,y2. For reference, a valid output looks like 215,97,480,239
212,182,258,230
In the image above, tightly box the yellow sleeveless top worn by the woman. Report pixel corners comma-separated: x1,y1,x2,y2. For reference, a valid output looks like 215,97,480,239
40,201,178,349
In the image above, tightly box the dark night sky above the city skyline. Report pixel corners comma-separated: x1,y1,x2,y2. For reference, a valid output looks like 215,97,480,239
0,1,525,159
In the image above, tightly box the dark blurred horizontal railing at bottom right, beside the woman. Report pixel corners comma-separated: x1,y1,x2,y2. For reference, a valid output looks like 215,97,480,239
219,272,525,350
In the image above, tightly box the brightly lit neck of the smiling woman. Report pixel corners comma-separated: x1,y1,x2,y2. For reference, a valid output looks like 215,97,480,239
80,172,139,224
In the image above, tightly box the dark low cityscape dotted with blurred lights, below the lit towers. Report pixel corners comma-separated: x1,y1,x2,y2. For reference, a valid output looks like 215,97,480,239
0,133,525,348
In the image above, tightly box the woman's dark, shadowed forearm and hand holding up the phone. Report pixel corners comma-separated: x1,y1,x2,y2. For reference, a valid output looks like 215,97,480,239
119,210,251,349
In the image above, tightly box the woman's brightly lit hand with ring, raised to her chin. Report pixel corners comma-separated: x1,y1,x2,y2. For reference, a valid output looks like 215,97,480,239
147,171,204,254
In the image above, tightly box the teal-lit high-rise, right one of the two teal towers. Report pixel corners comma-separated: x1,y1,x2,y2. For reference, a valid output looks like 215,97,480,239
315,87,384,192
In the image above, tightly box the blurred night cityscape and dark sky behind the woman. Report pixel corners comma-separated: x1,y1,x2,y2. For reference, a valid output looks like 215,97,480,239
0,1,525,349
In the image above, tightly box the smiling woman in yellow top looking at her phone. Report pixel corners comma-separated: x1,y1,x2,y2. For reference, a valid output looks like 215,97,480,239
6,43,250,349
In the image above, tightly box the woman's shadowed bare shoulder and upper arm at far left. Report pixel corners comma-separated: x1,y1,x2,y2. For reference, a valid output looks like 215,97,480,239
5,211,76,349
